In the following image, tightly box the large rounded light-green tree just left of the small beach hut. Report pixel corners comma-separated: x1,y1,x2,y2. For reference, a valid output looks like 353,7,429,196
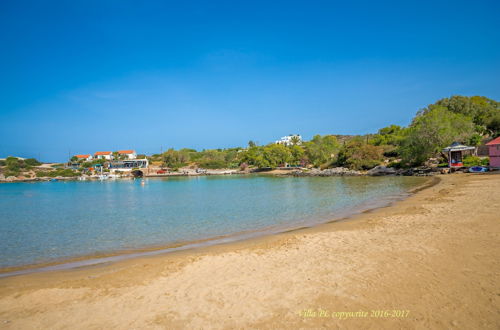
400,106,475,165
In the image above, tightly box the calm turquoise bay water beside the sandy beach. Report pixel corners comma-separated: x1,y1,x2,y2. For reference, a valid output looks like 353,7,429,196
0,176,423,267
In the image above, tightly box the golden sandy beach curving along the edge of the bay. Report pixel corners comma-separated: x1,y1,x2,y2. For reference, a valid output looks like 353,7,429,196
0,174,500,329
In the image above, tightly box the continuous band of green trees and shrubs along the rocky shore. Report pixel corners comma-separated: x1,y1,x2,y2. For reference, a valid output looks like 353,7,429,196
150,96,500,170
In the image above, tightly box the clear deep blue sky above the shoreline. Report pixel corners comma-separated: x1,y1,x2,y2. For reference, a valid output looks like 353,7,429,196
0,0,500,161
